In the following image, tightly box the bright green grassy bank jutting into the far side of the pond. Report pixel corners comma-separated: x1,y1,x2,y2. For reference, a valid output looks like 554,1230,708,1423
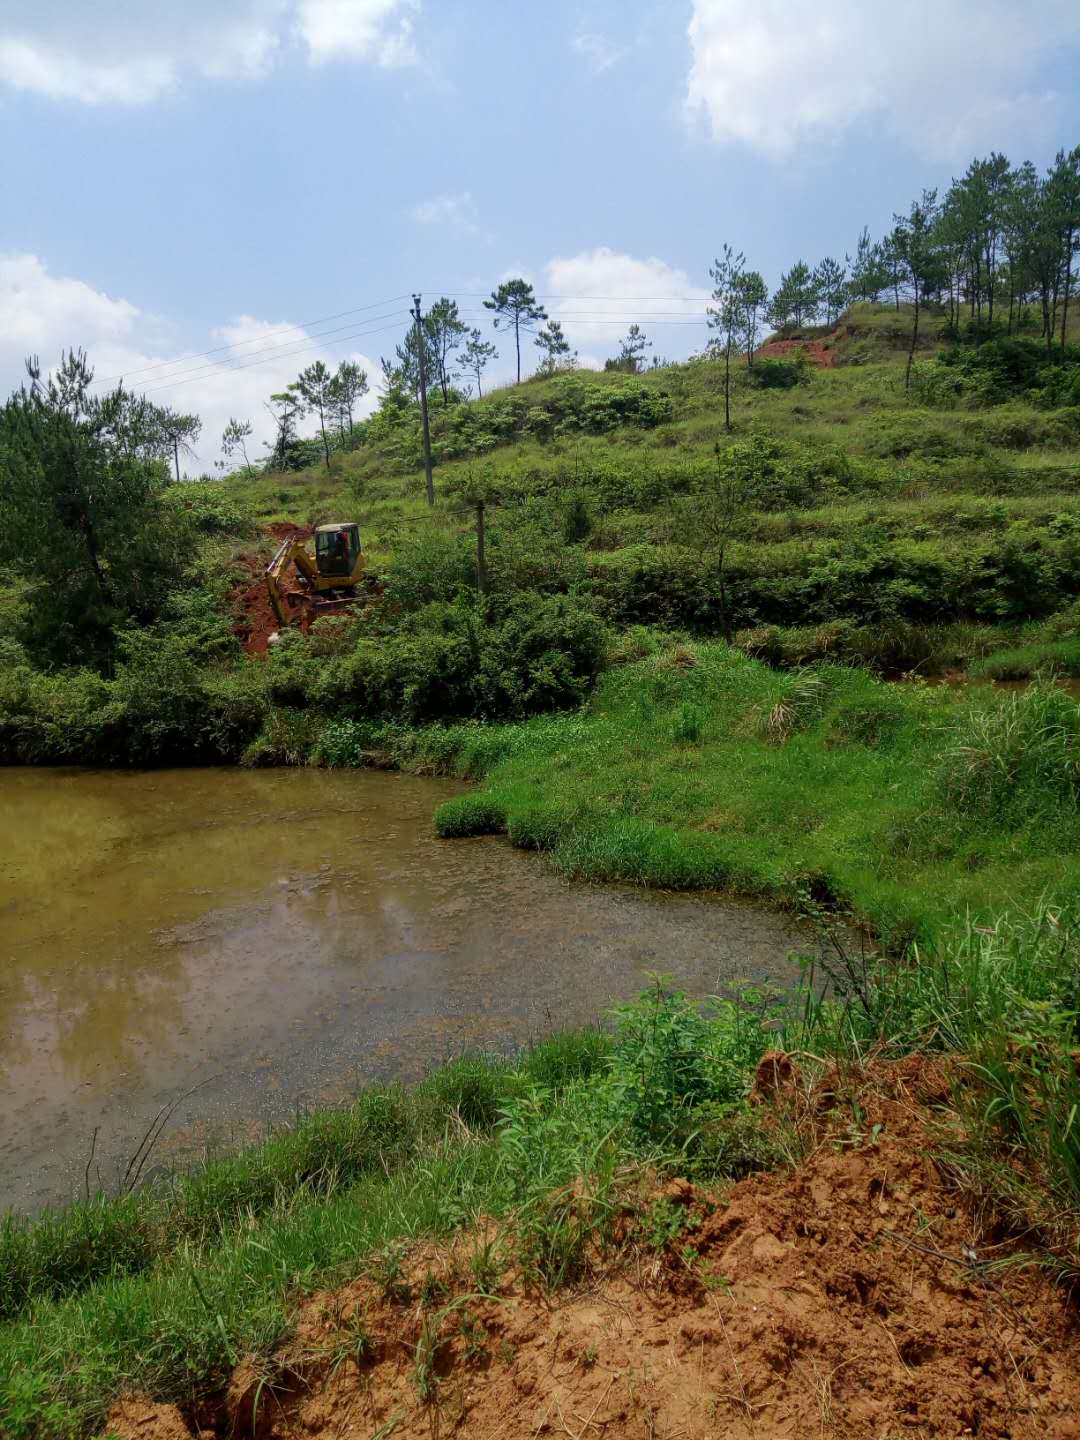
406,641,1080,950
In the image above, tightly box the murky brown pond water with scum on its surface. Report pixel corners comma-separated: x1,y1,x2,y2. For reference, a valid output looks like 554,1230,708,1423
0,769,806,1212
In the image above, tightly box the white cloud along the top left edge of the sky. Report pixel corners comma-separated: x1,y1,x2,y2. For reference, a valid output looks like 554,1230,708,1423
0,0,419,105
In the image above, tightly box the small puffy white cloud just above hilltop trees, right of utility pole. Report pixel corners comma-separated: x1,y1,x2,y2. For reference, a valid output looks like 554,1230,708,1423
544,245,708,347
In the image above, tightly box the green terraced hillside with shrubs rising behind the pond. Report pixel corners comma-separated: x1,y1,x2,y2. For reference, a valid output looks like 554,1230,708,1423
221,298,1080,675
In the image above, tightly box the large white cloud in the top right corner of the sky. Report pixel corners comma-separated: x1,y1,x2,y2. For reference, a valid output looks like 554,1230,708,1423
687,0,1080,158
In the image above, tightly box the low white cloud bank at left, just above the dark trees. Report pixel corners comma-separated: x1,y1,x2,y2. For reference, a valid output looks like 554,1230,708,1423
0,255,382,472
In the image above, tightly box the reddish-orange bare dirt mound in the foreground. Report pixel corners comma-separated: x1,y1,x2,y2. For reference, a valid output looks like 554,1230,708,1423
108,1057,1080,1440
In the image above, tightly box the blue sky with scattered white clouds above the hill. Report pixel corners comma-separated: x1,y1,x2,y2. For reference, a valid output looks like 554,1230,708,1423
0,0,1080,472
